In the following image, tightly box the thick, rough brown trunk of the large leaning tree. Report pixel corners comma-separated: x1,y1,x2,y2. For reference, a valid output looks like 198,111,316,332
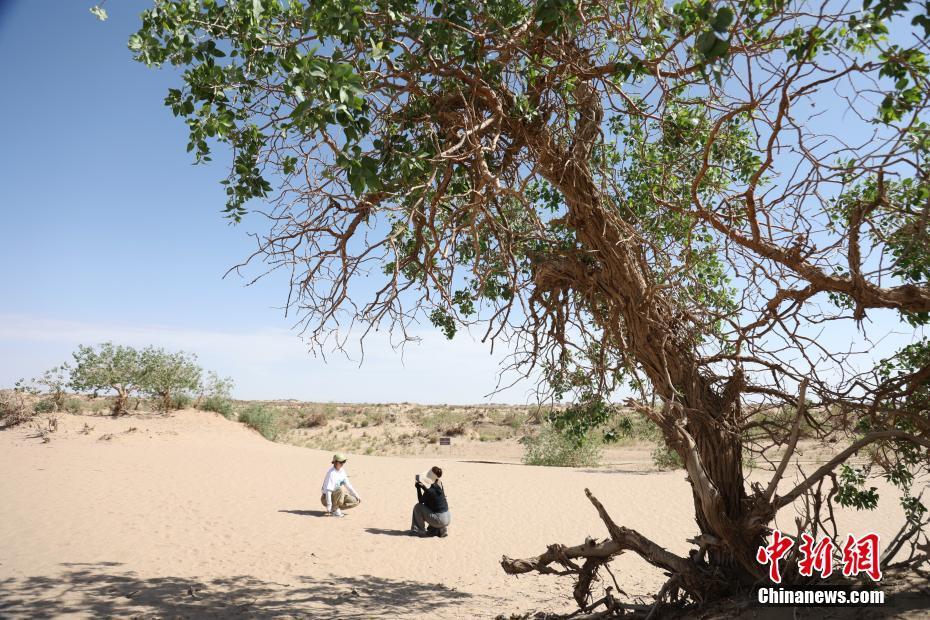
508,84,774,594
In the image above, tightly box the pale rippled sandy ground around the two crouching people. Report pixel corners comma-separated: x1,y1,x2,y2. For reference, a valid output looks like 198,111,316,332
0,411,930,618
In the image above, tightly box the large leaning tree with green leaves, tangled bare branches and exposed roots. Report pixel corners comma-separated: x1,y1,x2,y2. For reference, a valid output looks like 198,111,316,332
129,0,930,606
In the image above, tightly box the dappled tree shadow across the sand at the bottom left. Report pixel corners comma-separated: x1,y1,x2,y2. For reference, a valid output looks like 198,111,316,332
0,562,478,618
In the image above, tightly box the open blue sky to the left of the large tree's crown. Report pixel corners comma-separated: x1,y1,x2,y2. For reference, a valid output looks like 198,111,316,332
0,0,531,403
